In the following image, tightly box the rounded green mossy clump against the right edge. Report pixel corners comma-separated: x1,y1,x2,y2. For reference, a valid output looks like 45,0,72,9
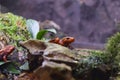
106,32,120,69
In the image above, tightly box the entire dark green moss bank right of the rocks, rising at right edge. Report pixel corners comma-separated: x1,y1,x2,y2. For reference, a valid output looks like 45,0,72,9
73,32,120,76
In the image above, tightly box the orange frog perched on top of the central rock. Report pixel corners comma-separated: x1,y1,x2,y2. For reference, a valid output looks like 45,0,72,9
49,37,75,47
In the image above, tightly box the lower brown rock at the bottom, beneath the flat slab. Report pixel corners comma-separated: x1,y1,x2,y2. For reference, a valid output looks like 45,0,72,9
33,61,74,80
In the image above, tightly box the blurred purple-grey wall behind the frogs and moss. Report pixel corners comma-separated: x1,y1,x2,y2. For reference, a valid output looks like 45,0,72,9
0,0,120,49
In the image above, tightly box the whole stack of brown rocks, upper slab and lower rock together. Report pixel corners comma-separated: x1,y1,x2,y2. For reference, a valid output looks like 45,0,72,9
18,40,77,80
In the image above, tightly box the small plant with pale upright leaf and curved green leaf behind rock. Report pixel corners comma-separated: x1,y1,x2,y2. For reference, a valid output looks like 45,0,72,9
26,19,57,41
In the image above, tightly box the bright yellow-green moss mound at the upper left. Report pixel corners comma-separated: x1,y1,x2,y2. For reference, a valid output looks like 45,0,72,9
0,13,30,45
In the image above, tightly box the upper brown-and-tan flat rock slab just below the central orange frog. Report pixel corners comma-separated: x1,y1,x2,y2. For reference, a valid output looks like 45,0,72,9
20,40,78,71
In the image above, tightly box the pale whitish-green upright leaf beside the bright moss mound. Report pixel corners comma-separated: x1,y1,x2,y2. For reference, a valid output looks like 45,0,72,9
26,19,40,39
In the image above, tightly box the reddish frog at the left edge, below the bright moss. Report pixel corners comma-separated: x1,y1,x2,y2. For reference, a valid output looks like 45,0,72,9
0,45,15,62
